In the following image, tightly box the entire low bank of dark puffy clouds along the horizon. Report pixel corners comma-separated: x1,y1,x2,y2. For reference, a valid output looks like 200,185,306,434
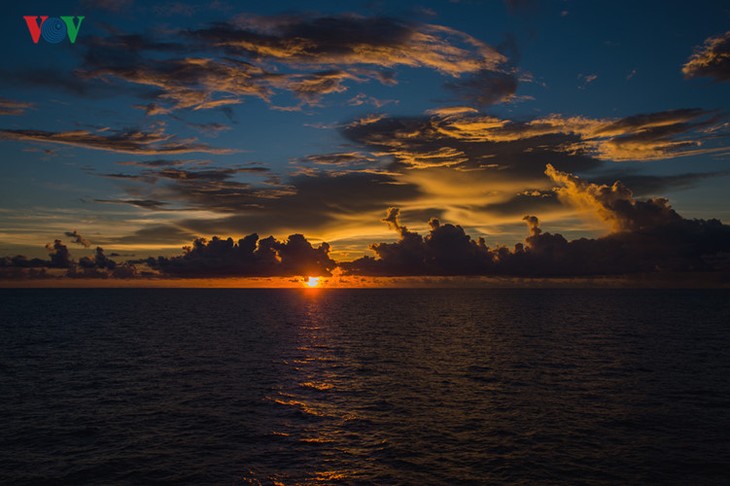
5,165,730,278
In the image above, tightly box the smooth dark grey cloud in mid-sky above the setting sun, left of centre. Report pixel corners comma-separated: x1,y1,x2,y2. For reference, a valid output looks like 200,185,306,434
97,164,421,243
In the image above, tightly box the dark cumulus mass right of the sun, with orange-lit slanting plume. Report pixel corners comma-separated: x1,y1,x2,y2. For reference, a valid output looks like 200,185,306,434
340,166,730,277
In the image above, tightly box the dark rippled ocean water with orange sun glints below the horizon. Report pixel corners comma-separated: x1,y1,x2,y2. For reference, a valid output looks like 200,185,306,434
0,289,730,485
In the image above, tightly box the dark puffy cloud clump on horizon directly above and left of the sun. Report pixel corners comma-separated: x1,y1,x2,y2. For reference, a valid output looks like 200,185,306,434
147,233,336,278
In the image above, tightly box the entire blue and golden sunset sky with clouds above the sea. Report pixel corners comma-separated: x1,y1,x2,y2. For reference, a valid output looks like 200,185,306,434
0,0,730,281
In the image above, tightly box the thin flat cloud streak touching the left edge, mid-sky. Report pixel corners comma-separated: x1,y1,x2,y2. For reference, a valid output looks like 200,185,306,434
0,128,232,155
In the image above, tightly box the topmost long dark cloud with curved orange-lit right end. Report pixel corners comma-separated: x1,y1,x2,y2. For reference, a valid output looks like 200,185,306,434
190,15,505,76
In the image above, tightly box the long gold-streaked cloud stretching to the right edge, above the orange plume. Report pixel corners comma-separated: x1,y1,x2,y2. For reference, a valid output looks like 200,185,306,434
343,107,728,174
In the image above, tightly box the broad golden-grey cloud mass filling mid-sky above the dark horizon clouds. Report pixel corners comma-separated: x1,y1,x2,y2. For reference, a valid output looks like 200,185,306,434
94,106,727,251
